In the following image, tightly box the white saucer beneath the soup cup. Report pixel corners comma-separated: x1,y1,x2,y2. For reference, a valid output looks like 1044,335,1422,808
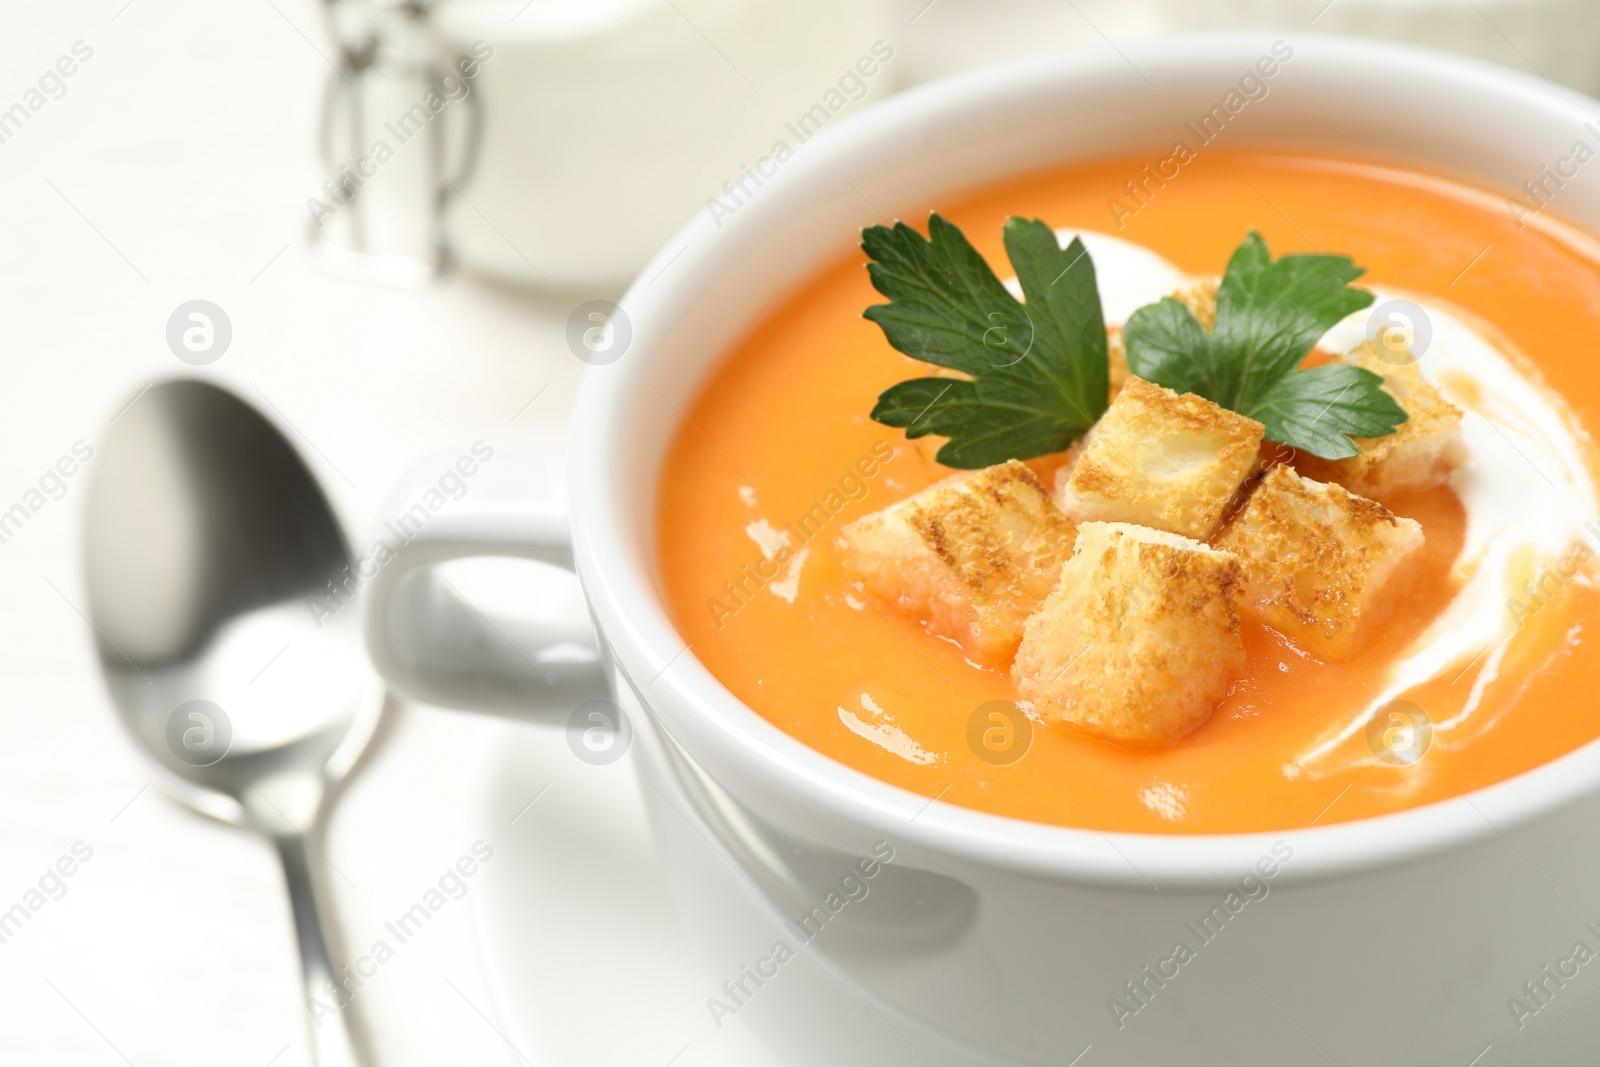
475,725,781,1067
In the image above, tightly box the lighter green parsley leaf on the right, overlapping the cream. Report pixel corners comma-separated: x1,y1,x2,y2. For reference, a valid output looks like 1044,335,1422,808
1123,230,1406,459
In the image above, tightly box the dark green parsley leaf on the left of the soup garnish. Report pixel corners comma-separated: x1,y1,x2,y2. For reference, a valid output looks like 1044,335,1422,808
861,214,1109,469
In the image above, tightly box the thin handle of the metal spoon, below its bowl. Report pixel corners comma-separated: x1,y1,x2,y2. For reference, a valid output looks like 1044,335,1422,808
274,833,368,1067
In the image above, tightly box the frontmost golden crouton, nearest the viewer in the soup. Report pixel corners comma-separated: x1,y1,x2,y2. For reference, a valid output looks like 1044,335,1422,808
1011,523,1245,744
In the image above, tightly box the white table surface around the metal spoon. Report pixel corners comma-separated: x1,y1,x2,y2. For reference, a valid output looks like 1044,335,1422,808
0,0,582,1067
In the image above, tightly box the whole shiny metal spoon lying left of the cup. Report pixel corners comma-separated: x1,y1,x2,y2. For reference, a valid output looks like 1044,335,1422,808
83,381,384,1067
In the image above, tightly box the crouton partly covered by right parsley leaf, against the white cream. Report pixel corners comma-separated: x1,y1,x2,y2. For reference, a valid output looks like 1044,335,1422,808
1296,344,1467,499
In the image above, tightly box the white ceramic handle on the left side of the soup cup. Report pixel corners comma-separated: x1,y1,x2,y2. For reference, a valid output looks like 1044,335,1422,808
364,450,611,718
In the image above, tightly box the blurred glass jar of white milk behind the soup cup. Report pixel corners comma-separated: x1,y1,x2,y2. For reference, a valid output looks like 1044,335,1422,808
434,0,898,293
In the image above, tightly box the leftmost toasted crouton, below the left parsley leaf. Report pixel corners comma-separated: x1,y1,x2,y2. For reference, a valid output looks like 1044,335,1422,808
838,459,1074,664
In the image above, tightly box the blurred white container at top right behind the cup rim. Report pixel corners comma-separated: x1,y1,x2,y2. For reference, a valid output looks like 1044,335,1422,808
1157,0,1600,96
